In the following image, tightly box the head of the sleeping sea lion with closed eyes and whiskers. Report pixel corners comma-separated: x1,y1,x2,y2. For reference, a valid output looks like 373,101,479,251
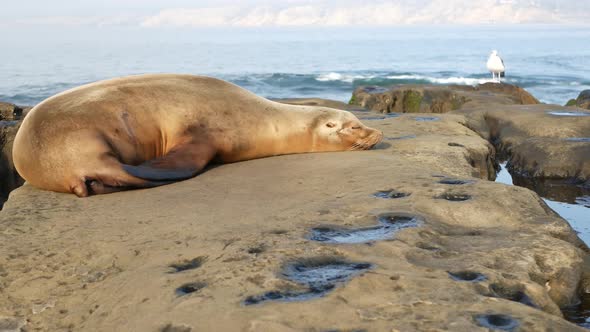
314,108,383,151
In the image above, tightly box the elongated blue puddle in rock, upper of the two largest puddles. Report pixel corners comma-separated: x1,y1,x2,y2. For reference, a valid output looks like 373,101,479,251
309,213,421,244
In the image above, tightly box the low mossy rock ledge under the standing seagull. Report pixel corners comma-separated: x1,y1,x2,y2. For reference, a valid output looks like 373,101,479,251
350,83,539,113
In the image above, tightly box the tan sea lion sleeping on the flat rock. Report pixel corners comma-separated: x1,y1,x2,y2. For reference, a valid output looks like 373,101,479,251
13,74,382,197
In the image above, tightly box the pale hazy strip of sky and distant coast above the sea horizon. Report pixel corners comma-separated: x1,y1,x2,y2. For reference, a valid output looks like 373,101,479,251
0,0,590,29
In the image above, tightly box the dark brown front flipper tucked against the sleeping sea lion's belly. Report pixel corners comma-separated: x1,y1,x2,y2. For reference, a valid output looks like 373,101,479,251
123,143,215,181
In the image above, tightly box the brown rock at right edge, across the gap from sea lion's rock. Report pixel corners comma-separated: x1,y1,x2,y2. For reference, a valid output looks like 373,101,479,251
457,104,590,182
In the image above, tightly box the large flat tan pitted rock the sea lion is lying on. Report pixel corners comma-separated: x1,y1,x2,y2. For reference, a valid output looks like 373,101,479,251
0,101,588,331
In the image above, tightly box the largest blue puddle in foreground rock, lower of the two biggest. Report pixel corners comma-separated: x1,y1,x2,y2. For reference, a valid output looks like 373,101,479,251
244,257,373,305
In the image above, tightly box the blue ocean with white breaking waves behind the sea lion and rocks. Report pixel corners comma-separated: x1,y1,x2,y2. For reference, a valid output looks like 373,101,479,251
0,25,590,105
